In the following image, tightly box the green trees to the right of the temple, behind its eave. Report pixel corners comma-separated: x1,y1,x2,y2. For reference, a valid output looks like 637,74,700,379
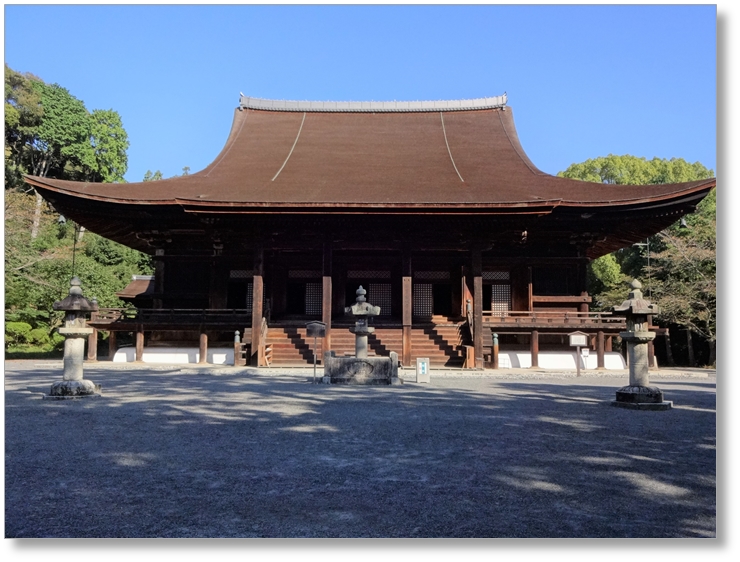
558,154,717,363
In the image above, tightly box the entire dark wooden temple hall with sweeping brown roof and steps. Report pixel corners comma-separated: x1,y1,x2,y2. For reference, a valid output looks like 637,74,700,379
27,94,714,368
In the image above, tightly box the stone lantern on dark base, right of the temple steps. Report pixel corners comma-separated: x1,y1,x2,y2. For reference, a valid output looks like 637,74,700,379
612,279,673,410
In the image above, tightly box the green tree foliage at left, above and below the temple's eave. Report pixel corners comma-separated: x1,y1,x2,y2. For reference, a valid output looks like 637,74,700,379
4,65,147,346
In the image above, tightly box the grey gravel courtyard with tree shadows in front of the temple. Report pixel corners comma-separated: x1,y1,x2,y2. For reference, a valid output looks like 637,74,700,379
5,361,716,538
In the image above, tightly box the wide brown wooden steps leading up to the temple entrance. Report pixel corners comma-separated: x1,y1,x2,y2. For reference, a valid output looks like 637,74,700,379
266,322,465,368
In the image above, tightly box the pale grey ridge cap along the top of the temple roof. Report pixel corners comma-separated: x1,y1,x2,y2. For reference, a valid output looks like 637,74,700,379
239,92,508,113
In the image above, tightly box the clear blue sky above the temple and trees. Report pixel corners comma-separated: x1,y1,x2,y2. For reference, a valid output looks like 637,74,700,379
4,5,717,181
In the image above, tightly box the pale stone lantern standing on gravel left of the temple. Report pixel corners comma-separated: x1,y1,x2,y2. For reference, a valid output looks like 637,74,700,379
50,277,100,398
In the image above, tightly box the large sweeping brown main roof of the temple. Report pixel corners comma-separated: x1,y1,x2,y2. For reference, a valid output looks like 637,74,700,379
27,99,715,212
